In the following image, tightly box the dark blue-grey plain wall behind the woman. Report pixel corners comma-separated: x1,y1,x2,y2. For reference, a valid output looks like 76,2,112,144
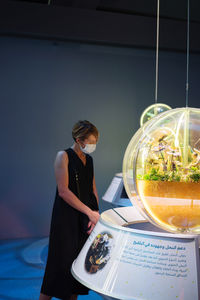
0,37,200,239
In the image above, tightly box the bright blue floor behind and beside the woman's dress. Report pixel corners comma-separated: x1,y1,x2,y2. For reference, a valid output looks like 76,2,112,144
0,238,102,300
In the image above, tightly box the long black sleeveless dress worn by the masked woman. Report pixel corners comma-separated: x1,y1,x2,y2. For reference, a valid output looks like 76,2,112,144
41,148,98,300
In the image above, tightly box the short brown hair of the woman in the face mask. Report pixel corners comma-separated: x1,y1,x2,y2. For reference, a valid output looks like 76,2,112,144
72,120,99,142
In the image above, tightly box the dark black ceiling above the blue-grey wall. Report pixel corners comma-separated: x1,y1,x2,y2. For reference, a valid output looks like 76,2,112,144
0,0,200,53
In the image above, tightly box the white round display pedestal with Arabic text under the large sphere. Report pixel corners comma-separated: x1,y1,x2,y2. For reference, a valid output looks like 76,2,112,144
72,207,200,300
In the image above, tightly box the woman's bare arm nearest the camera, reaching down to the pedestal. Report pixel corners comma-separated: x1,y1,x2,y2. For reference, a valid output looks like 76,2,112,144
55,151,99,224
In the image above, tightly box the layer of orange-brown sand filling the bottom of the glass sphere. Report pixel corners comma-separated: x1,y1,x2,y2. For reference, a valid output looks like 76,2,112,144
137,180,200,233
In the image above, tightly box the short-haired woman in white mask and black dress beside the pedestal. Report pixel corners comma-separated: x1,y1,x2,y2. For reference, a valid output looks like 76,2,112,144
39,121,99,300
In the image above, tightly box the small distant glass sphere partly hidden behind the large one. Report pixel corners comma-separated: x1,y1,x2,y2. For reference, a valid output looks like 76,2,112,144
140,103,171,126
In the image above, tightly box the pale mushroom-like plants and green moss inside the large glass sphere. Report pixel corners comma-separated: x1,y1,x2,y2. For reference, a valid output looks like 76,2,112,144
137,134,200,183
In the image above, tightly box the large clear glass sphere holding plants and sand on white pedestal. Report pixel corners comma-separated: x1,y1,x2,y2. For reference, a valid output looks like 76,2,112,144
123,108,200,234
